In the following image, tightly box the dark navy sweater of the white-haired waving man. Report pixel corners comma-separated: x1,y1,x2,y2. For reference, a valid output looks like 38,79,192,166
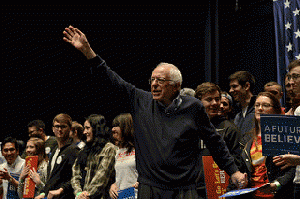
89,56,238,189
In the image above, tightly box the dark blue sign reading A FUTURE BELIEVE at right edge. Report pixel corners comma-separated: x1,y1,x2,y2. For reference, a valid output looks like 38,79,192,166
260,114,300,156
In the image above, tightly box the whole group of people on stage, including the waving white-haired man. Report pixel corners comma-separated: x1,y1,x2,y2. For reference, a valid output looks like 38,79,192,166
0,26,300,199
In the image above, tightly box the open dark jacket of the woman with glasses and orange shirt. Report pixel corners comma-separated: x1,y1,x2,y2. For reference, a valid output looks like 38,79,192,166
228,138,296,199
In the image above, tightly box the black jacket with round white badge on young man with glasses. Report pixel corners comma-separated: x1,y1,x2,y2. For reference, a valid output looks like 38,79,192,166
41,142,79,199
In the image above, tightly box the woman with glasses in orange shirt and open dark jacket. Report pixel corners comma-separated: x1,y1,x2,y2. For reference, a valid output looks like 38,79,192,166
229,92,295,198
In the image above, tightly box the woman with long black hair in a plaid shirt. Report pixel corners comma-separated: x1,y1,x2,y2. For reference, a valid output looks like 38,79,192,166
71,114,117,199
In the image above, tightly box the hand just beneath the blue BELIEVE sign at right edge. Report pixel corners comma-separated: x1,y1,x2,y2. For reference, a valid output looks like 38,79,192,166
273,154,300,170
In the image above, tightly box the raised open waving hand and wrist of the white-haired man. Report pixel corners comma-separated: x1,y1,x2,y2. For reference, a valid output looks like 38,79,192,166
63,25,96,59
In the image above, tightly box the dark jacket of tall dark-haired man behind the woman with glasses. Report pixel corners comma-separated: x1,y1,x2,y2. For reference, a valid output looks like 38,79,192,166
234,96,256,135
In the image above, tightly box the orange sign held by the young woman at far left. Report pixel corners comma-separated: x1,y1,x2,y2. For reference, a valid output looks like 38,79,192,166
23,156,38,198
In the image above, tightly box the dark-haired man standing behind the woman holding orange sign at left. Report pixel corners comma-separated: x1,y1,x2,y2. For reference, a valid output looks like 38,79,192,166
27,120,57,158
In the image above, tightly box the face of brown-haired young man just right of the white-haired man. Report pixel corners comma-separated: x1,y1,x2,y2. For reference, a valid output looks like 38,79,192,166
201,91,220,119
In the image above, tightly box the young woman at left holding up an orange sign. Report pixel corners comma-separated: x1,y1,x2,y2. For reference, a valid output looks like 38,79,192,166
18,137,48,198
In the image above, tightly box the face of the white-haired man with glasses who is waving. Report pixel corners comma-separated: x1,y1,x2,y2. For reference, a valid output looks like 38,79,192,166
150,66,179,106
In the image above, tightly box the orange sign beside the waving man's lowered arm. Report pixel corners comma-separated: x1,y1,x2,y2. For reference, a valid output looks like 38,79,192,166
202,156,229,199
